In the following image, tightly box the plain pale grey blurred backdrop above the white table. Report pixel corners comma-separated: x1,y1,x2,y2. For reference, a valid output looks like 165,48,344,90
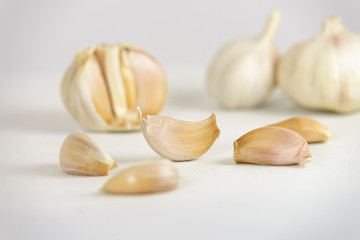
0,0,360,78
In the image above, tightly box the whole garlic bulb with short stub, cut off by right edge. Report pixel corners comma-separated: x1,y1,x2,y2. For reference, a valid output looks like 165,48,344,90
277,17,360,113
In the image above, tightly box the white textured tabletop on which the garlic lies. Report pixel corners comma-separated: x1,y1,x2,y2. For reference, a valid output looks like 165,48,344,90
0,69,360,240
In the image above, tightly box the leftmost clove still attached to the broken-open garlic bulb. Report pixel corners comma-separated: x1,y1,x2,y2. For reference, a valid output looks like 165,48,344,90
61,48,113,130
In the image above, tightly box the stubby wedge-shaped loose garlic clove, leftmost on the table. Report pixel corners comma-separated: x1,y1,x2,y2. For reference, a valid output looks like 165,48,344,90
59,130,117,176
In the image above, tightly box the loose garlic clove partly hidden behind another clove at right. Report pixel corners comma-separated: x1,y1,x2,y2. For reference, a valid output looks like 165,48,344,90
270,117,331,143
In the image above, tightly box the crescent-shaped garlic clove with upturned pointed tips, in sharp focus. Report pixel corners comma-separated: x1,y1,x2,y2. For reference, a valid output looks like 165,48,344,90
139,109,220,161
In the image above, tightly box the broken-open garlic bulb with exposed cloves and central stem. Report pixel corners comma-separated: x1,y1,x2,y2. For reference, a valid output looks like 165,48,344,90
61,44,167,131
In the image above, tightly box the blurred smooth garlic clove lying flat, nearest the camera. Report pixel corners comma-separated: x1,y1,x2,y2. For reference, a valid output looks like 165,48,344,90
102,162,180,194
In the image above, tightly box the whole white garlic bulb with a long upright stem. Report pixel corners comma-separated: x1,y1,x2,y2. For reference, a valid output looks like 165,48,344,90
207,11,280,108
